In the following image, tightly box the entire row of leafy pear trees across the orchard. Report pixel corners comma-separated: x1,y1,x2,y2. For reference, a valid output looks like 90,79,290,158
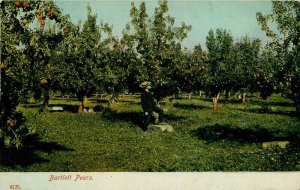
0,0,300,150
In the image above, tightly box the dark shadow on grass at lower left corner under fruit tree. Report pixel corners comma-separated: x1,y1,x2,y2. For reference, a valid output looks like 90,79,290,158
0,135,74,168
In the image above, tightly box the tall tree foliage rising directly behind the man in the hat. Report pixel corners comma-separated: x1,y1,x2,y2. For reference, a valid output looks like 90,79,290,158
126,1,191,99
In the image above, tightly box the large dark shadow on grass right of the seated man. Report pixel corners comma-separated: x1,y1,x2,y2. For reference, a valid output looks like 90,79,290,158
191,124,288,143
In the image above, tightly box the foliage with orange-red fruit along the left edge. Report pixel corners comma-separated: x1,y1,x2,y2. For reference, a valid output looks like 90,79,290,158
0,0,64,149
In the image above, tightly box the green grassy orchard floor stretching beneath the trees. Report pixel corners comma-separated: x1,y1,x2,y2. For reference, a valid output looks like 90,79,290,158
0,95,300,172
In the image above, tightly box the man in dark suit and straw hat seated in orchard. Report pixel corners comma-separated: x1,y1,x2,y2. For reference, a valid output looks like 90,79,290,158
140,81,165,131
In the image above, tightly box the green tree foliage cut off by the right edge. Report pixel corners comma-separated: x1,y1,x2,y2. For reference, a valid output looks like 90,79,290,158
257,1,300,112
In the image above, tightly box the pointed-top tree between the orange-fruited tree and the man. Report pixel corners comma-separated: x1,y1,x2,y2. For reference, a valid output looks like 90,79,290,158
51,6,105,111
